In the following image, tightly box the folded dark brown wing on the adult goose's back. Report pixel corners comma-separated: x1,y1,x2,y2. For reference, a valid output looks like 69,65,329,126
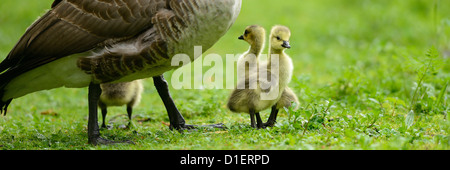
0,0,166,73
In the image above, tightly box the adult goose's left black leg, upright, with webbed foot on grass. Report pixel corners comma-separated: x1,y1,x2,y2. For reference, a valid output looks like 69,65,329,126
88,83,133,145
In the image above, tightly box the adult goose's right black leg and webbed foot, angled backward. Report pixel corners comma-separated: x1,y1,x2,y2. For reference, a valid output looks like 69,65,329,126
153,75,226,130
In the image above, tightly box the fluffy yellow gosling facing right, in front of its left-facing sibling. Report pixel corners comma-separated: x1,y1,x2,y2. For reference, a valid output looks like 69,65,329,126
227,26,293,128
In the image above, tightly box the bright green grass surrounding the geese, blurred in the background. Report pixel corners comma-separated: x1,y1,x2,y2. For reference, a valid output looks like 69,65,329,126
0,0,450,150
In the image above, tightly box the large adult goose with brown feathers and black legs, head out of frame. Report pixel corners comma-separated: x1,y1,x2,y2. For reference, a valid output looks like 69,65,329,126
0,0,242,145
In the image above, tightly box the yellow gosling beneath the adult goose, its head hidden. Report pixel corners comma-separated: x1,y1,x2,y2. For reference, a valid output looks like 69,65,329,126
98,80,144,128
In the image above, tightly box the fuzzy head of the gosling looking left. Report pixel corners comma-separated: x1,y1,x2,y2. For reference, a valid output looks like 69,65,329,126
238,25,266,45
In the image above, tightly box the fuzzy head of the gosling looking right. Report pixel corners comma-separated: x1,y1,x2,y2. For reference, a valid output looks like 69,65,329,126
270,25,291,50
